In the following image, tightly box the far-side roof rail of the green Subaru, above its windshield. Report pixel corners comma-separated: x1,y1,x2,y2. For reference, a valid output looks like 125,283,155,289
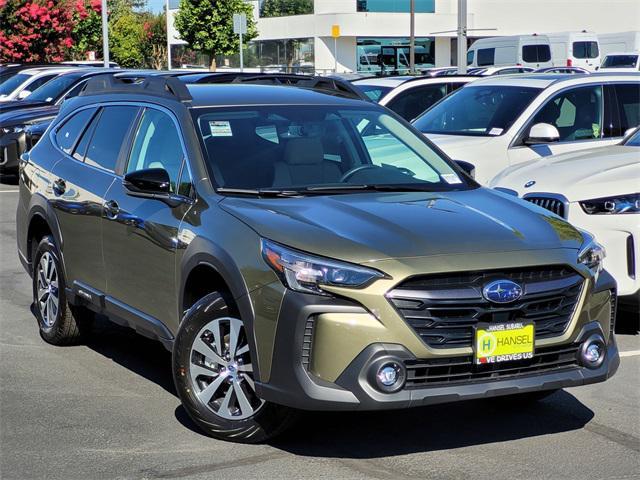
231,73,371,102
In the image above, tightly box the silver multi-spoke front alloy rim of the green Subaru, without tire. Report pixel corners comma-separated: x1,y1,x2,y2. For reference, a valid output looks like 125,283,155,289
189,317,264,420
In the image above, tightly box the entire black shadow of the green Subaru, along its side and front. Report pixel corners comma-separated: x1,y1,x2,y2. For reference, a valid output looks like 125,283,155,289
87,318,594,459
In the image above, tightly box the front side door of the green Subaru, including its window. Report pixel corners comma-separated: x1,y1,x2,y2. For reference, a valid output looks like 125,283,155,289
103,109,190,327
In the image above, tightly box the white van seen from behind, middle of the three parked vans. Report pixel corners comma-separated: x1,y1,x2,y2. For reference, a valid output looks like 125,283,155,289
545,30,600,71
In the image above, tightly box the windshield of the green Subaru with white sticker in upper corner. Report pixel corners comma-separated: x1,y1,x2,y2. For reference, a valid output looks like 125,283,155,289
193,105,469,194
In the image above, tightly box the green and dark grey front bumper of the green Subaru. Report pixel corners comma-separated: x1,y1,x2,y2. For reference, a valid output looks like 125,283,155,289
256,272,619,410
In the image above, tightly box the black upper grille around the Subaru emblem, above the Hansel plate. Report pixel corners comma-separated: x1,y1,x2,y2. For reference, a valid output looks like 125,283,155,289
387,266,584,348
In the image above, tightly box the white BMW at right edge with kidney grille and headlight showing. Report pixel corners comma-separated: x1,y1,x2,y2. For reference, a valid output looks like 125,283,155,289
490,128,640,303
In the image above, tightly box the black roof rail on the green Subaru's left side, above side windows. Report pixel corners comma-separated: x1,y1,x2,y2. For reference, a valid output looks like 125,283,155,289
79,71,193,102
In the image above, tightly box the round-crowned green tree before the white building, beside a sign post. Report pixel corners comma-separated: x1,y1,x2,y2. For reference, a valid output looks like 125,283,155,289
175,0,258,70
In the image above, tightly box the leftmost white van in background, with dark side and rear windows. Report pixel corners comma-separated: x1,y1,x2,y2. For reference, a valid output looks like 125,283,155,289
467,34,553,68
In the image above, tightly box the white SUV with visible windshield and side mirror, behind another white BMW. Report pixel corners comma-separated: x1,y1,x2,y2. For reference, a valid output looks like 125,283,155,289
413,73,640,183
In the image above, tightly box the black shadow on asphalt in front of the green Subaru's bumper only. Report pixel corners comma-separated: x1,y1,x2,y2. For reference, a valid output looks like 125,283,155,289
272,391,594,459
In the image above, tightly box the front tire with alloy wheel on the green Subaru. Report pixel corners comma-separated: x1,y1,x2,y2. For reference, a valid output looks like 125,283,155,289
173,293,295,443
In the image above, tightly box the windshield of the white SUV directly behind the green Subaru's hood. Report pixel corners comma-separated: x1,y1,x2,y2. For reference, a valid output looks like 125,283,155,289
414,85,540,137
